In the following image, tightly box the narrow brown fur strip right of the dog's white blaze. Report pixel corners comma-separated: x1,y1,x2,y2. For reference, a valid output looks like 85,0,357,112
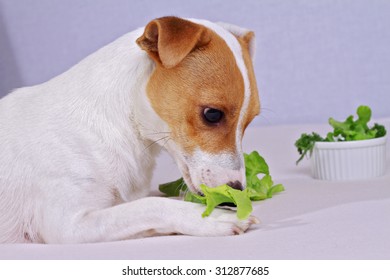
237,31,260,133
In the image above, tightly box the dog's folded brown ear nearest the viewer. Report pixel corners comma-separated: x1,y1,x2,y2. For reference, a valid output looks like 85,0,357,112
137,17,210,68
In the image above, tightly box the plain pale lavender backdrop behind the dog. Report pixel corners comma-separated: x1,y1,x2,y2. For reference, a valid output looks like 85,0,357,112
0,0,390,125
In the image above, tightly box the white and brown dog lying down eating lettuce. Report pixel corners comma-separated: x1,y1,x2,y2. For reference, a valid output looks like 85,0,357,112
0,17,260,243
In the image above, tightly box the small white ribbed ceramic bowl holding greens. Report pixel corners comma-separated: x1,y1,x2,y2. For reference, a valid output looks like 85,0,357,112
311,137,386,180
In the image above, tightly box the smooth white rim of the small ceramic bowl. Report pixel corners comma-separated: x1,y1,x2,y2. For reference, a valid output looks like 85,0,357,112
314,135,387,150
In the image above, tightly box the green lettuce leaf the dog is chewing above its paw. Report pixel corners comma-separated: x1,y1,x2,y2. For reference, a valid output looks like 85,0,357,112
159,151,284,219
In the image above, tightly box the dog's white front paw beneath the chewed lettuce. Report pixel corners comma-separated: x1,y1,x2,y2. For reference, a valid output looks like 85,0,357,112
179,204,260,236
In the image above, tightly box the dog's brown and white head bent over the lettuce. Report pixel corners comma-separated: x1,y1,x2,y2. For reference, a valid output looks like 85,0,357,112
137,17,260,193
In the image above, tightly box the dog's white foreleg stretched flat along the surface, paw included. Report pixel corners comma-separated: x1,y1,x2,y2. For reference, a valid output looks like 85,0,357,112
45,197,257,243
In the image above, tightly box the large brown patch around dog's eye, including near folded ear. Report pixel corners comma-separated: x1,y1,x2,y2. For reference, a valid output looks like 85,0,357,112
137,18,245,154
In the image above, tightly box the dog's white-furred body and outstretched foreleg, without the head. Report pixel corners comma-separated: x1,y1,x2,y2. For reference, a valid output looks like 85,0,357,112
0,20,254,243
